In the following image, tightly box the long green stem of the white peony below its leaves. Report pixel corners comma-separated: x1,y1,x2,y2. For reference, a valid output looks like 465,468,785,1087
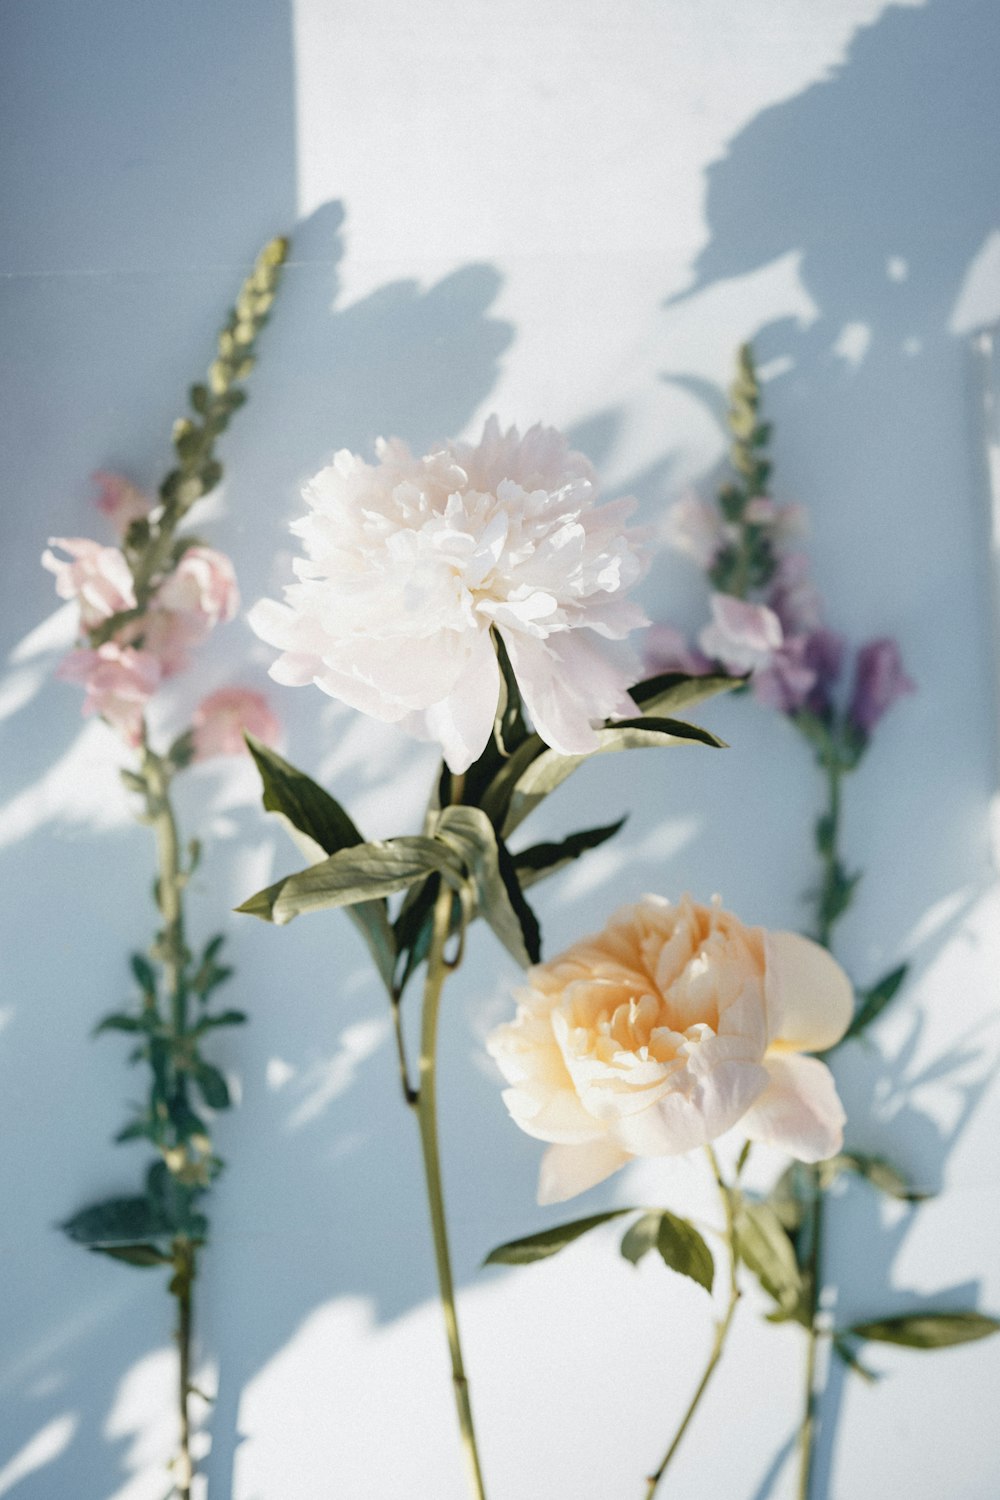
415,882,486,1500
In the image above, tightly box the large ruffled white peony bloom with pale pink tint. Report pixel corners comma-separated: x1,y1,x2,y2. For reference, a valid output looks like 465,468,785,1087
249,417,646,773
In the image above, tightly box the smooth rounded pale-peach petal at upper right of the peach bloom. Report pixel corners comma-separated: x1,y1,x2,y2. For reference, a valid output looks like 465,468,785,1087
765,933,855,1052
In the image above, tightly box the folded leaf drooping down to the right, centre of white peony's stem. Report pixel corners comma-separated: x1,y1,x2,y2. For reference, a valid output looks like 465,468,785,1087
435,806,541,968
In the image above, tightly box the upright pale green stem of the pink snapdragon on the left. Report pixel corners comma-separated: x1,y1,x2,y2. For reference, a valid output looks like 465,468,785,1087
142,749,196,1500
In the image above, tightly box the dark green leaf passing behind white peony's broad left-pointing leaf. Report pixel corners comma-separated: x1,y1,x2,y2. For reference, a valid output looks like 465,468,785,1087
246,734,396,992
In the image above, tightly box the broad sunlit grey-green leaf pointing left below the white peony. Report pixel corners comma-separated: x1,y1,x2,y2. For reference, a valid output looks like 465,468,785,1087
237,834,463,927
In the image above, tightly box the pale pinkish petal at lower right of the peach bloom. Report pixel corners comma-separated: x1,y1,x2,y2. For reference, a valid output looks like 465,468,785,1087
742,1058,846,1161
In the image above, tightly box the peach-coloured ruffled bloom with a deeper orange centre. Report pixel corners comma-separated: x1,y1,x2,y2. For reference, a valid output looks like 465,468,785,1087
487,896,853,1203
